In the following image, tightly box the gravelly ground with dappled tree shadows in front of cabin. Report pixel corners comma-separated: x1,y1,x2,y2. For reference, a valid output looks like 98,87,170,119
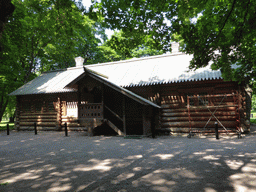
0,127,256,192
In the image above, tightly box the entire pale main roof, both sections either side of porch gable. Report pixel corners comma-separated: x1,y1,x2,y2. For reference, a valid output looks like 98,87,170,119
10,53,222,95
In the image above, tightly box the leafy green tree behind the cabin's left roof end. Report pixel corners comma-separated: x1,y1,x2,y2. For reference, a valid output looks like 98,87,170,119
0,0,102,121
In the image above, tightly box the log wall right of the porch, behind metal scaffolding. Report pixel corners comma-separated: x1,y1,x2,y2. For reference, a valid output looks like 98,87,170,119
129,80,249,132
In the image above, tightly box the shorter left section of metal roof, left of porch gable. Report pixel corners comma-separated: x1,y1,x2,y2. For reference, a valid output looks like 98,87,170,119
10,67,84,95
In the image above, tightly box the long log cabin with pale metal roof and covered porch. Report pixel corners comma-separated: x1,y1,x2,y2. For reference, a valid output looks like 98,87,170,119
10,47,251,135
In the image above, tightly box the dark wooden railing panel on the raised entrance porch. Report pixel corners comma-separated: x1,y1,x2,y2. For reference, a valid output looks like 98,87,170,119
79,103,103,118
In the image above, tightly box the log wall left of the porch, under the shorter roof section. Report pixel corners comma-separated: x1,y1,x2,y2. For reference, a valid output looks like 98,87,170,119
16,93,86,130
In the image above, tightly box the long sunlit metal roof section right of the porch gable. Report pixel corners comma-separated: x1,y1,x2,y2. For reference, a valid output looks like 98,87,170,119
85,53,222,87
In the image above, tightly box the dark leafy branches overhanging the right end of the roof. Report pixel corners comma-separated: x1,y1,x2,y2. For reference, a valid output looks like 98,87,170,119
91,0,256,88
